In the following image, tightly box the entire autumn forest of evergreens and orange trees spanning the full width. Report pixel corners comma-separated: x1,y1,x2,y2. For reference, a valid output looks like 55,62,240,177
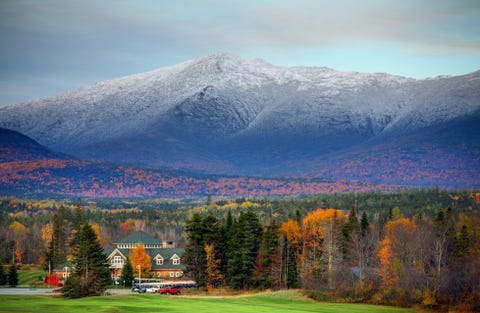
0,188,480,310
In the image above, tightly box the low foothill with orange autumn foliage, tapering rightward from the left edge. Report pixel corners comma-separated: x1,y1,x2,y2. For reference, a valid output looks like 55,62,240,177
0,129,382,198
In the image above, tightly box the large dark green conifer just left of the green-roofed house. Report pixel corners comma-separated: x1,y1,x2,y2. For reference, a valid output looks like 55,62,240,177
62,223,111,298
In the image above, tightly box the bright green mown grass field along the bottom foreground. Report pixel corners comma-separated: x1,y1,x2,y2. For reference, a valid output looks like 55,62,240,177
0,291,417,313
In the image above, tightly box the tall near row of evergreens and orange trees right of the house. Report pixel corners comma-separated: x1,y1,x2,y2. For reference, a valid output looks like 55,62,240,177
183,207,480,310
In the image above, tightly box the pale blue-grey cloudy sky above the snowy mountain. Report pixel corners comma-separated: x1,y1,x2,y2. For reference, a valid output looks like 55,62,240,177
0,0,480,105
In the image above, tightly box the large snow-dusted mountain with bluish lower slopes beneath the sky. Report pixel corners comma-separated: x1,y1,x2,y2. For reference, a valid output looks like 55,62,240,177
0,54,480,187
